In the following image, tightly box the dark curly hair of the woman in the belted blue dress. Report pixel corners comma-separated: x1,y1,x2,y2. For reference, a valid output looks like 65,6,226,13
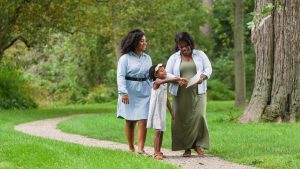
121,29,145,54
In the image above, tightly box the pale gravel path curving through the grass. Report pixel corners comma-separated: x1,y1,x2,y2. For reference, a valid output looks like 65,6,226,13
15,115,255,169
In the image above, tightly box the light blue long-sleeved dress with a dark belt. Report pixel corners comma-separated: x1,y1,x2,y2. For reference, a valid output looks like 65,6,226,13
117,52,152,120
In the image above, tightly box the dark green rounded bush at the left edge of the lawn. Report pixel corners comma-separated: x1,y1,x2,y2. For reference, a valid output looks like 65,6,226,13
0,63,37,109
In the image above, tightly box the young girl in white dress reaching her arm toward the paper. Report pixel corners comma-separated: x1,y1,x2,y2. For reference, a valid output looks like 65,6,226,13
147,64,183,160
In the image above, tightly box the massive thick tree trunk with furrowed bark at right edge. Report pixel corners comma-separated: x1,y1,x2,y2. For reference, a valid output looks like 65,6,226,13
240,0,300,123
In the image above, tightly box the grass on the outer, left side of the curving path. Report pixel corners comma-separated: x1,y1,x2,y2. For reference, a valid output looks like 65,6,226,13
0,104,176,169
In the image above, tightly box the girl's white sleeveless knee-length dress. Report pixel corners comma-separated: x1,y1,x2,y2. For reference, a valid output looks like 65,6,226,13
147,84,167,131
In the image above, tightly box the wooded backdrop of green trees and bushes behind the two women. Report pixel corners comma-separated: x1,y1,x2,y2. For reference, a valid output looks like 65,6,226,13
0,0,255,108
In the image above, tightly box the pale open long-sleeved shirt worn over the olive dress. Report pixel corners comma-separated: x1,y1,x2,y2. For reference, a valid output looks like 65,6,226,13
166,49,212,96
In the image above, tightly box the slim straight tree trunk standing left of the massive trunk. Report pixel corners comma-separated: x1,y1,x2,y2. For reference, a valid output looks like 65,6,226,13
234,0,246,107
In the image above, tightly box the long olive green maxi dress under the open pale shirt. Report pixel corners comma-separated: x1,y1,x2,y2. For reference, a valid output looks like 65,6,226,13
172,59,209,151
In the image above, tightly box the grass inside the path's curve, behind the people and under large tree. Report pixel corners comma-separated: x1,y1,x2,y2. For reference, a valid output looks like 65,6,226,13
59,101,300,169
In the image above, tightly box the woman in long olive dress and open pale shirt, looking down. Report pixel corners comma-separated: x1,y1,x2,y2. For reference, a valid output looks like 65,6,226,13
166,32,212,157
